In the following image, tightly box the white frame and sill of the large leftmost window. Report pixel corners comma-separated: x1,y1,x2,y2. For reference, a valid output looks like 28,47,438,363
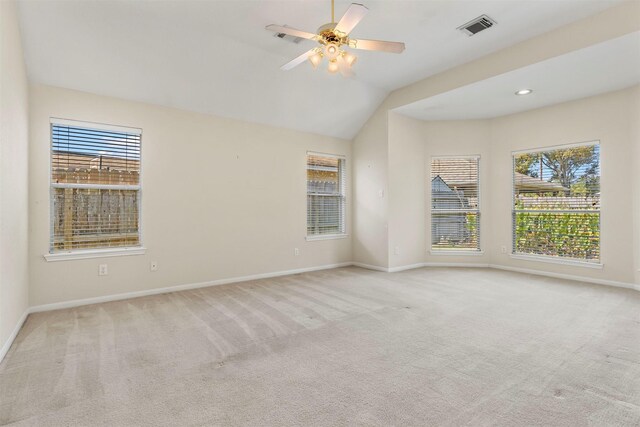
43,117,146,262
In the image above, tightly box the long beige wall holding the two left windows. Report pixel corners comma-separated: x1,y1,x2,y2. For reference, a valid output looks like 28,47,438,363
29,85,353,305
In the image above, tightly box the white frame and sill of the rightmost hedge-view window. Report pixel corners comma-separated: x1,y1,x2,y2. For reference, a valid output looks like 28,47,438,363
509,139,604,269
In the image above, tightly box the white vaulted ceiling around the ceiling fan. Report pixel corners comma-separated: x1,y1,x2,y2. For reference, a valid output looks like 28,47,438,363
20,0,620,139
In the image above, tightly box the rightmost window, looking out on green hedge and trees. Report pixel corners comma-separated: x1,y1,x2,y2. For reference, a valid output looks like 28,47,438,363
513,143,600,263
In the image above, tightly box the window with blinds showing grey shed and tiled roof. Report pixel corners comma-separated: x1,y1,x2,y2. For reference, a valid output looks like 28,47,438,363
430,156,480,251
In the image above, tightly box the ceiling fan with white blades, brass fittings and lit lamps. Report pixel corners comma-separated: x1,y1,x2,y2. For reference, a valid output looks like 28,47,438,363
265,0,404,77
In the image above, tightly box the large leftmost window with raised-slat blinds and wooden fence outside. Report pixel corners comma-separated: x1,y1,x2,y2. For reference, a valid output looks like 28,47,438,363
50,120,141,253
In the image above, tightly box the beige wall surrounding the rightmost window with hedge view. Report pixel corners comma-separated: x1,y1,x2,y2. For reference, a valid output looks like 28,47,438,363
490,86,640,283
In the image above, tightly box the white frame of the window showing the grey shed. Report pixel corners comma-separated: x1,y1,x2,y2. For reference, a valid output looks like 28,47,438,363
427,154,484,256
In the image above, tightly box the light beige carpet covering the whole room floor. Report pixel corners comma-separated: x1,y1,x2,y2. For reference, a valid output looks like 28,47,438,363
0,268,640,426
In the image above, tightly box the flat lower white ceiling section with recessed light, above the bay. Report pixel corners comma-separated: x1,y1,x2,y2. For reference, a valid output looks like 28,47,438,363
395,32,640,120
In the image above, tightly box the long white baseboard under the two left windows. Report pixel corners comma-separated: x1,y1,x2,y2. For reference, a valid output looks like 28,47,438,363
29,262,353,313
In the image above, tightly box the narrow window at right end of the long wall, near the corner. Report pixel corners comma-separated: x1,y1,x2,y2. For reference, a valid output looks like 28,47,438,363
307,153,346,238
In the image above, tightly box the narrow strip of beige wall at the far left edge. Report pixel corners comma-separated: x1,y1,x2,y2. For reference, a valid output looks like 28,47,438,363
0,1,29,359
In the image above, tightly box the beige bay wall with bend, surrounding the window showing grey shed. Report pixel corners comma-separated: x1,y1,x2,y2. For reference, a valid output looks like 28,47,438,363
389,116,492,269
